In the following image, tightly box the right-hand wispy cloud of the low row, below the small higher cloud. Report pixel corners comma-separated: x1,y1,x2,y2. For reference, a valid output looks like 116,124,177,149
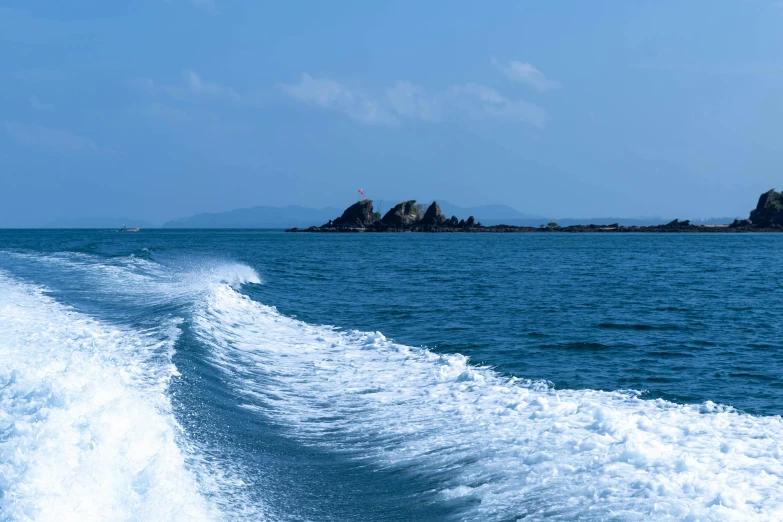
449,83,549,127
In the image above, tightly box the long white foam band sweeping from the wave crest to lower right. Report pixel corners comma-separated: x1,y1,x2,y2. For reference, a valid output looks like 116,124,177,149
194,285,783,520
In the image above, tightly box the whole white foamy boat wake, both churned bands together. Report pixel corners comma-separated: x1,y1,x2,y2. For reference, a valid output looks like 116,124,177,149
0,250,783,520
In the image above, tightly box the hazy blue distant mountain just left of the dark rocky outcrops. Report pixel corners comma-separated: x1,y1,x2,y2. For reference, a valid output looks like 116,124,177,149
163,205,343,228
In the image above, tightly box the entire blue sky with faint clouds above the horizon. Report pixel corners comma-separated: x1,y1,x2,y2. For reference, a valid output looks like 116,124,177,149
0,0,783,227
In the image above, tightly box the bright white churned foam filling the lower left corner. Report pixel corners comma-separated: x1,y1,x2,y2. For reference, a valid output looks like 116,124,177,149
0,272,218,521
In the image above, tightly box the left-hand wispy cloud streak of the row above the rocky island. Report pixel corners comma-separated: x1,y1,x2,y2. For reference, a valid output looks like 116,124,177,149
279,73,399,125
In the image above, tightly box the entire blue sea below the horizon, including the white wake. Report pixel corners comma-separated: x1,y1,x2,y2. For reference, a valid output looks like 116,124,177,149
0,230,783,521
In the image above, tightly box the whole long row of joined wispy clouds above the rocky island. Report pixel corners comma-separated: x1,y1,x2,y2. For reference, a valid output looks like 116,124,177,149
280,74,549,126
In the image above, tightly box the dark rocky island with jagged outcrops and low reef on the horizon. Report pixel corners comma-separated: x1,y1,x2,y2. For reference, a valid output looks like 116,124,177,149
286,189,783,232
